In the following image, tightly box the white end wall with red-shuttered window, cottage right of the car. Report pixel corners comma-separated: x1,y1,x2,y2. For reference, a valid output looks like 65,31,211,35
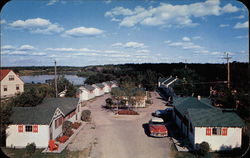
194,127,242,150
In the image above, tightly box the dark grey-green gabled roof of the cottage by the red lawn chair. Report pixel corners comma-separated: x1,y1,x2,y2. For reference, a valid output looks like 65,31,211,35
10,98,79,124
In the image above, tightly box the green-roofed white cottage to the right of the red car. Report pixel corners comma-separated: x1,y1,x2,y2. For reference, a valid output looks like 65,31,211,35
173,97,244,151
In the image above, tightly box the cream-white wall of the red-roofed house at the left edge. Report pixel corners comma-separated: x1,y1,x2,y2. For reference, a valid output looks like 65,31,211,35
1,71,24,98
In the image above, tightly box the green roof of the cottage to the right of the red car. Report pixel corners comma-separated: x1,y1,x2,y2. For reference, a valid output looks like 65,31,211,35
174,97,244,127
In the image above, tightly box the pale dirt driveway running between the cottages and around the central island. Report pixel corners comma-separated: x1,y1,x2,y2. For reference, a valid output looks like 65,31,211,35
86,92,171,158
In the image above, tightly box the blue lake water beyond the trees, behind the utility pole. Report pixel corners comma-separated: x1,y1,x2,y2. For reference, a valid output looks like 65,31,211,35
21,75,86,85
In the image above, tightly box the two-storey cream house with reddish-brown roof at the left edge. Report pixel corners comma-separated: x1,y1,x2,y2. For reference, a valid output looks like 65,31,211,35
0,69,24,98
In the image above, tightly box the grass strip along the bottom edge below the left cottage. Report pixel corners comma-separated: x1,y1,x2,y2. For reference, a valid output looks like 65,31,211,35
1,148,90,158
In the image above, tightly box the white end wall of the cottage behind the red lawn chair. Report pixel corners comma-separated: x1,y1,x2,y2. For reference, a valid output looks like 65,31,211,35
6,125,49,148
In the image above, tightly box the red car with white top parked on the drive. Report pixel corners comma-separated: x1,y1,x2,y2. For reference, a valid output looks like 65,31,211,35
149,117,168,137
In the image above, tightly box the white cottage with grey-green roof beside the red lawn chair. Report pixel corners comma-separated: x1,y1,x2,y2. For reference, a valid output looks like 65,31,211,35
6,98,81,148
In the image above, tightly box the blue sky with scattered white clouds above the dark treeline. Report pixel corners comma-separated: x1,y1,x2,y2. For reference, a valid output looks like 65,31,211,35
1,0,249,67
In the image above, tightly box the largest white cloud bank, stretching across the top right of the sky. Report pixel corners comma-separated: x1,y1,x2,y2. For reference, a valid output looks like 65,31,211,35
105,0,239,27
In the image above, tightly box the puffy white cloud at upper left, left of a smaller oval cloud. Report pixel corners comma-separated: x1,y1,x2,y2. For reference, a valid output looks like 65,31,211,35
9,18,64,34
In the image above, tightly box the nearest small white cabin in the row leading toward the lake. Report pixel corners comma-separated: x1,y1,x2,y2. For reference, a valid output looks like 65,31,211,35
77,85,95,102
